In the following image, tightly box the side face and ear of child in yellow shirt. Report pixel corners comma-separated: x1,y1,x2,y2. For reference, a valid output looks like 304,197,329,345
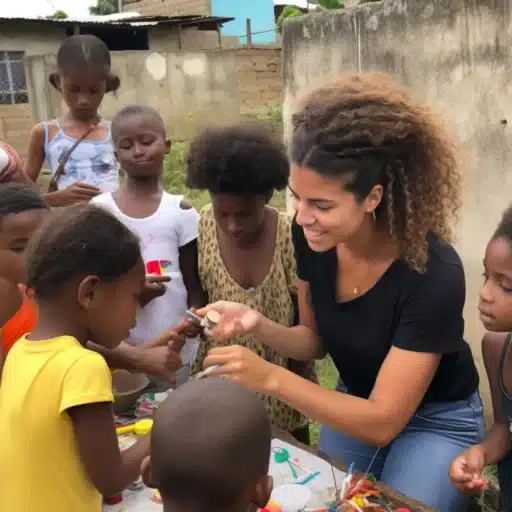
82,260,146,349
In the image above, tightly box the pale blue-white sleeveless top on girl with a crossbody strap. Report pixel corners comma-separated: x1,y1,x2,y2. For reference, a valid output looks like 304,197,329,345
43,119,119,192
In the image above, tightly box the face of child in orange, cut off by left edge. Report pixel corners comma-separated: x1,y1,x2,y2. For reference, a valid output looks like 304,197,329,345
0,209,49,284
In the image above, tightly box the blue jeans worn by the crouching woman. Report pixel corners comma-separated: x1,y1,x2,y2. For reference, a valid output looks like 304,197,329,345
319,383,484,512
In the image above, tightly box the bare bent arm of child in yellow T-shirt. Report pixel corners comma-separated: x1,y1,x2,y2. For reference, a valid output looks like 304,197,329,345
67,403,151,496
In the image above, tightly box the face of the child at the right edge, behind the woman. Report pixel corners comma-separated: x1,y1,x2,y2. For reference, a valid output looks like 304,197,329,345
478,237,512,332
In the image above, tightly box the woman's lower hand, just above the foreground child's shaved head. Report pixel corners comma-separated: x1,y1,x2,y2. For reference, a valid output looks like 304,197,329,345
203,345,281,394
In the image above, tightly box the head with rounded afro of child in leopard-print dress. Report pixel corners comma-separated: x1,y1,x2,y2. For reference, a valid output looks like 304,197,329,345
187,123,289,243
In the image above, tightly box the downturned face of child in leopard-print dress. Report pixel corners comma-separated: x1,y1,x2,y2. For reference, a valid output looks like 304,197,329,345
211,194,267,245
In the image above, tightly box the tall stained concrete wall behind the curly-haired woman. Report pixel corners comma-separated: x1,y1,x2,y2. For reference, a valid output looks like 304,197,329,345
283,0,512,420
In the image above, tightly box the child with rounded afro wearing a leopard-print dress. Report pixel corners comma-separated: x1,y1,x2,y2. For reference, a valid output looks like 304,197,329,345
187,123,317,444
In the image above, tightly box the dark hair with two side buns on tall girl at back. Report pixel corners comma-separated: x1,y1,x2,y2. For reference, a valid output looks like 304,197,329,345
49,34,121,92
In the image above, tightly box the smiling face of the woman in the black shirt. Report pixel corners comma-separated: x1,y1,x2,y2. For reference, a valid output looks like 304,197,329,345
289,165,382,252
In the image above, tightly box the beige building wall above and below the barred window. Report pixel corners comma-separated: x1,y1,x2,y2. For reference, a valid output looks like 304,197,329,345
0,23,66,158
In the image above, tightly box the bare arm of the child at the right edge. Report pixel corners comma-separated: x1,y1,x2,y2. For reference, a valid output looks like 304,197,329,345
482,333,510,464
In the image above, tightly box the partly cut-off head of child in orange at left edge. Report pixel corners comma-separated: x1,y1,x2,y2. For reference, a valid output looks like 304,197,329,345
0,183,50,284
